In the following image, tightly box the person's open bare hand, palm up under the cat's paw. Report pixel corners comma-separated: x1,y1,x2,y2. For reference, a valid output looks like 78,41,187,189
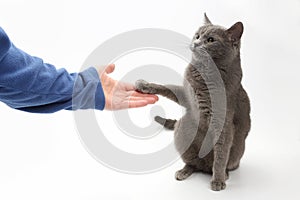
98,64,158,110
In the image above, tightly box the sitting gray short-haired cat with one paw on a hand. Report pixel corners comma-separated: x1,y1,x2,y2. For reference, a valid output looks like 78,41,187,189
136,15,250,191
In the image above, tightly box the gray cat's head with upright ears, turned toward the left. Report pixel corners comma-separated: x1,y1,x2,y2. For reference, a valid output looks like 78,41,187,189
190,14,244,62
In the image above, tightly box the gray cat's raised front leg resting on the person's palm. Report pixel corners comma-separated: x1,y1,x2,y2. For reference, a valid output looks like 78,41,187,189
135,80,187,106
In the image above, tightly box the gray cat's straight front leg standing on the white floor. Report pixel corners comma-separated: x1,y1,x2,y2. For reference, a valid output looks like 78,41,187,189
211,124,233,191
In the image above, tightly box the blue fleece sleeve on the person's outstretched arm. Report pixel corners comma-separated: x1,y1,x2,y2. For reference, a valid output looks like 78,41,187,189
0,27,105,113
